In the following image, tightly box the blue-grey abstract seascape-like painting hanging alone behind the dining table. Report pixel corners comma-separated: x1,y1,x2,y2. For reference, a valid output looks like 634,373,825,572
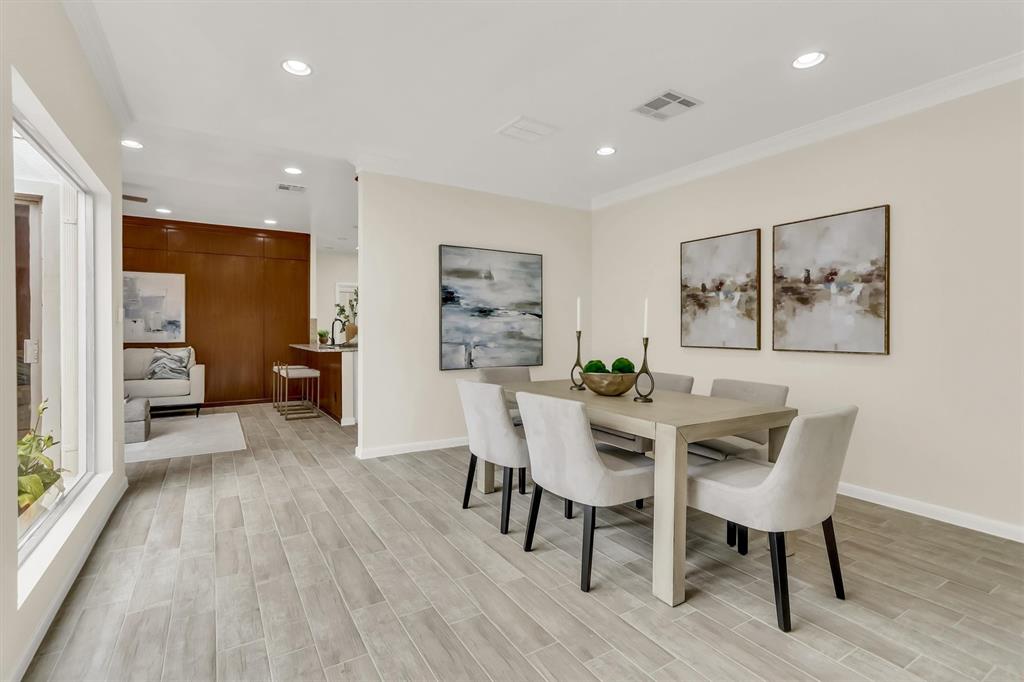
438,245,544,370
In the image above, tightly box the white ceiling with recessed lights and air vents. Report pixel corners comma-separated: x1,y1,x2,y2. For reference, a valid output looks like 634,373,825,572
69,0,1024,225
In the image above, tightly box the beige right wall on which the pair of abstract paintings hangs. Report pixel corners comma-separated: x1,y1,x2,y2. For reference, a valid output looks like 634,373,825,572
593,81,1024,535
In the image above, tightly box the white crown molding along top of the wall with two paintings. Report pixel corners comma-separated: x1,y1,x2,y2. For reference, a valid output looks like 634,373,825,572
591,52,1024,210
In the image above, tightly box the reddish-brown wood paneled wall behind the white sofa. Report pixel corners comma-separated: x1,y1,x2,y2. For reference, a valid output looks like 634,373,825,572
123,215,309,404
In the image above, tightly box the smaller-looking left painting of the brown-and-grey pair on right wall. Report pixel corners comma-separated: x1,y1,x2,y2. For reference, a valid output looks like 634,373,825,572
679,229,761,350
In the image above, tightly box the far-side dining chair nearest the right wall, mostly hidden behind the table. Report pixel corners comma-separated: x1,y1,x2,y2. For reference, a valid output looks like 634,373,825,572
687,379,790,554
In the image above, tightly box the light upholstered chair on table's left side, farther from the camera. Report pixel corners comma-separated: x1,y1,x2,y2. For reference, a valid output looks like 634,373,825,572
457,380,529,535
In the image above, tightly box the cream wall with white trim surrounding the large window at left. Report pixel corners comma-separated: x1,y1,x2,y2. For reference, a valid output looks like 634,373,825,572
0,2,125,680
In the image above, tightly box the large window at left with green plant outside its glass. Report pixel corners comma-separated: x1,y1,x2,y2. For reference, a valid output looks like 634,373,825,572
8,123,92,560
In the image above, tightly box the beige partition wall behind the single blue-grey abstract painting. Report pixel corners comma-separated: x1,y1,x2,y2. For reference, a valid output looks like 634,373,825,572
358,173,590,456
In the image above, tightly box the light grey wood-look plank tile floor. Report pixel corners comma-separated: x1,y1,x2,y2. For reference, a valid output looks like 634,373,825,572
26,404,1024,682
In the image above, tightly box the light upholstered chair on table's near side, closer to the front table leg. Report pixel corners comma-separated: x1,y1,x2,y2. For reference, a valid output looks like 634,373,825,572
516,392,654,592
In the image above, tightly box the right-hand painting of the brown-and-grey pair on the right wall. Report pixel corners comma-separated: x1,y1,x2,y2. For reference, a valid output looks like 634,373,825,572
772,205,889,354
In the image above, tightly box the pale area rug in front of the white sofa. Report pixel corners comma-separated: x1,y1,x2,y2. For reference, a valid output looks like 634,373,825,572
125,412,246,462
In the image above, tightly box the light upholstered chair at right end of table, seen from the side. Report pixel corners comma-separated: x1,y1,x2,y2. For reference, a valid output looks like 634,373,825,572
688,407,857,632
